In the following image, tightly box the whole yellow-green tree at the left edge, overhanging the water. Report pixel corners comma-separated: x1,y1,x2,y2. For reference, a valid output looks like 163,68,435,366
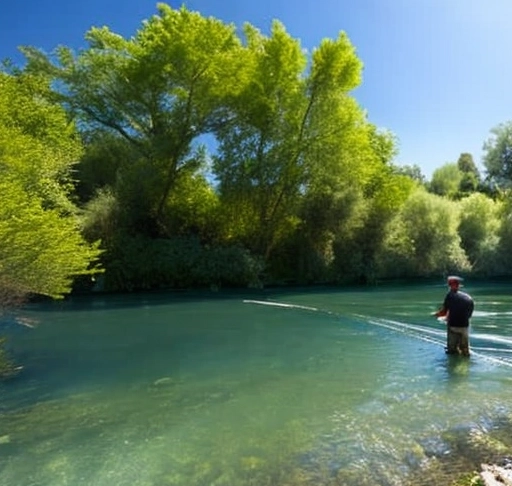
0,73,99,304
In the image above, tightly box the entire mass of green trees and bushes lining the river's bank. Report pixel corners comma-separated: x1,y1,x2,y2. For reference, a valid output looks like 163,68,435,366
9,4,512,286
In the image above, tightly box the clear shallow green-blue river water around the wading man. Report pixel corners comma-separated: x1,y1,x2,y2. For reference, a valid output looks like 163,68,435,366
0,285,512,486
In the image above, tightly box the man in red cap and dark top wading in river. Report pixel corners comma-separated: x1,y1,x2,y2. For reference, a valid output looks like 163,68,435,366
434,276,475,356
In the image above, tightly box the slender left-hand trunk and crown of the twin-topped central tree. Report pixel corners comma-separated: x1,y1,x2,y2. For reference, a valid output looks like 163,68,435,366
213,22,306,255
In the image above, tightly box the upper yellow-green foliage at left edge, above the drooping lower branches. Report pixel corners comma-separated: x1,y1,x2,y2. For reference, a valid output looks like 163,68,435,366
0,72,81,212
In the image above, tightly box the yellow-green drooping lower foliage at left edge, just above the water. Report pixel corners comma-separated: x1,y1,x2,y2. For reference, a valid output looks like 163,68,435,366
0,179,102,297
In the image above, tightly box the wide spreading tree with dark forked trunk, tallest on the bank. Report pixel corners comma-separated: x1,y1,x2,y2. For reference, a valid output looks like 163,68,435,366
24,4,245,233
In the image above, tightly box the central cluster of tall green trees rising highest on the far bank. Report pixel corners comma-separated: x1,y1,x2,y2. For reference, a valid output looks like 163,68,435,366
10,4,422,286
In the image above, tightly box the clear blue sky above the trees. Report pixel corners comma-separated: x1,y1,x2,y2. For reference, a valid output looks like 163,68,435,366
0,0,512,178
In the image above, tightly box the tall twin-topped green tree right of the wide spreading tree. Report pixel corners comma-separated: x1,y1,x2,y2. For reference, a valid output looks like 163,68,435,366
214,22,378,266
